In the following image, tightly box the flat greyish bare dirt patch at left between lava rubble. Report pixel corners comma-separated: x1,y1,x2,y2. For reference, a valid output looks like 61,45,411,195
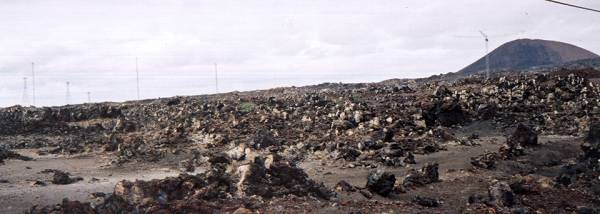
0,150,178,213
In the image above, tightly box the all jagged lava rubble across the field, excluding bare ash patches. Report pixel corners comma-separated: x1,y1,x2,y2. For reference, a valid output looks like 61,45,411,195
0,68,600,213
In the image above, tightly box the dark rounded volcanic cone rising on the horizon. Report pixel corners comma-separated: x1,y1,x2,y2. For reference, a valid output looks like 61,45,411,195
459,39,600,75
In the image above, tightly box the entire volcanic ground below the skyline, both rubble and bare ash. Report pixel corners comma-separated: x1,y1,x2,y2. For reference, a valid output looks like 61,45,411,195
0,69,600,213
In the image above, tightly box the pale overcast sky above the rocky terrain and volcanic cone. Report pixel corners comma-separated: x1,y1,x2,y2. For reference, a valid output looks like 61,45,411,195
0,0,600,106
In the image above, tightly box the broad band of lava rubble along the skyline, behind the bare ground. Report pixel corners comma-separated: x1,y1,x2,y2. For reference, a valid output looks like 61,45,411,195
0,72,600,166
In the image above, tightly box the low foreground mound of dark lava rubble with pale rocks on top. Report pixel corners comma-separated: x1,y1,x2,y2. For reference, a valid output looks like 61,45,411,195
29,155,334,213
